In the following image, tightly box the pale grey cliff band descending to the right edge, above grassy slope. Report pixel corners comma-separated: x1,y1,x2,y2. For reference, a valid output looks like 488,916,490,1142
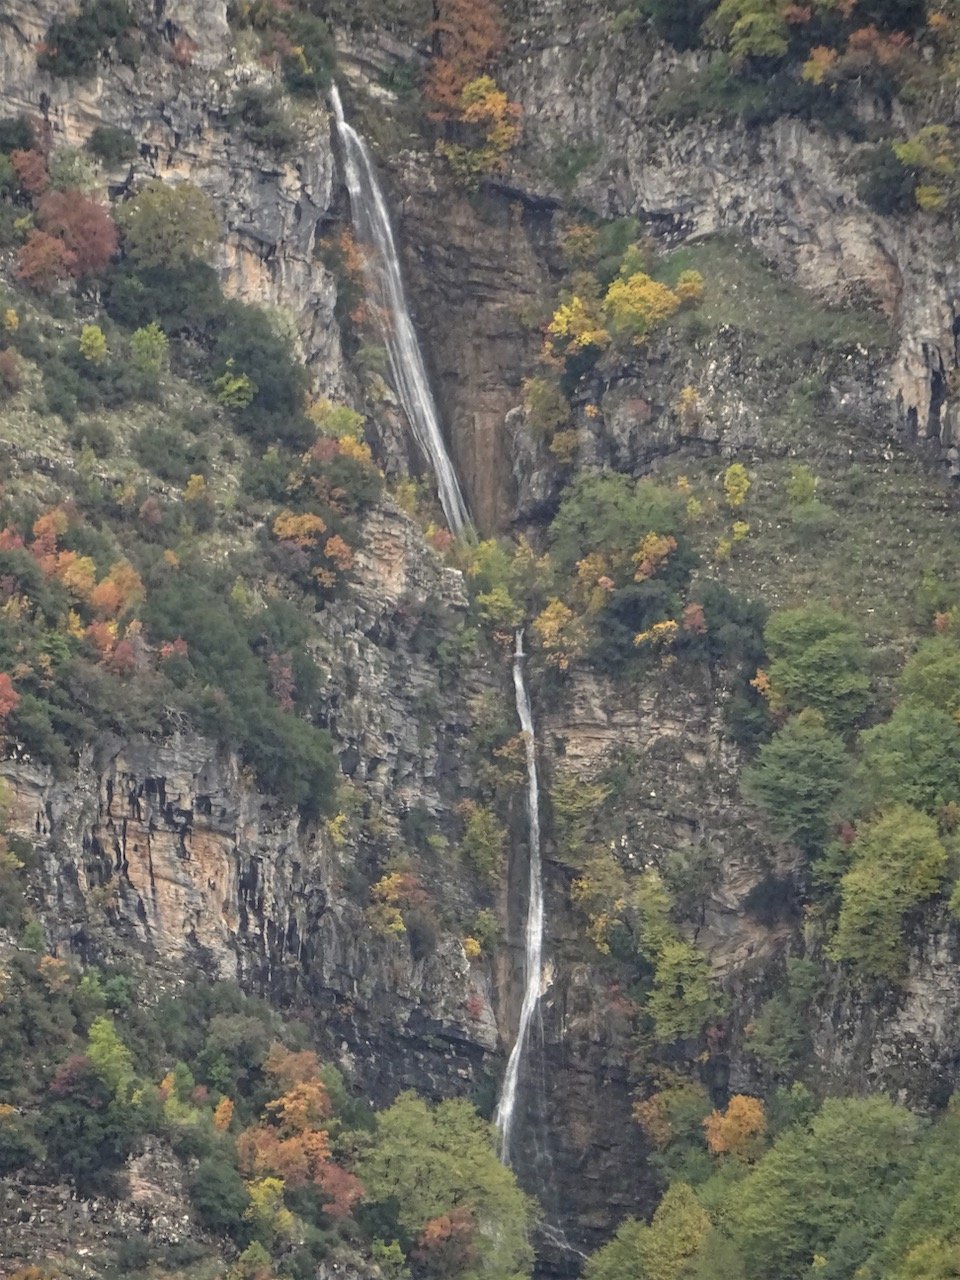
506,0,960,463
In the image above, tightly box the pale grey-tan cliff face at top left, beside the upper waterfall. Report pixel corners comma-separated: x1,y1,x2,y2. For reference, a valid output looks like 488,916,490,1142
0,0,343,393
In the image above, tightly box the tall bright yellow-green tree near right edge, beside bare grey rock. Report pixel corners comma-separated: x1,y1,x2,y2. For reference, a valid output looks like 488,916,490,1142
831,805,947,978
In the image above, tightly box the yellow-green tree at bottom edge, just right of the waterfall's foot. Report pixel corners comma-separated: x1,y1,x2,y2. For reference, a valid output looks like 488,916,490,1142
584,1183,710,1280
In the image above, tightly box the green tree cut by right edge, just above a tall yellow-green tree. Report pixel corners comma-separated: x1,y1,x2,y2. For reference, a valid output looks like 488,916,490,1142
858,703,960,813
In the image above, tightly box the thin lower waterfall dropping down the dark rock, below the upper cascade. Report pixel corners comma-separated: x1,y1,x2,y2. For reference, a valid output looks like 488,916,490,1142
494,631,543,1165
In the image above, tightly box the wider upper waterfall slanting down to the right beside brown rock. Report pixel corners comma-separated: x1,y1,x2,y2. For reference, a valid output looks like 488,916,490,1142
330,84,471,534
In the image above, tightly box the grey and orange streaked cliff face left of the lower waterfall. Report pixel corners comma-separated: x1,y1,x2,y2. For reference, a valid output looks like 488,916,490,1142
3,512,497,1098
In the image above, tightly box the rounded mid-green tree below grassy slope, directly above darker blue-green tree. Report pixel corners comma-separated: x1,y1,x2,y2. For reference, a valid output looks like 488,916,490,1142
764,602,870,732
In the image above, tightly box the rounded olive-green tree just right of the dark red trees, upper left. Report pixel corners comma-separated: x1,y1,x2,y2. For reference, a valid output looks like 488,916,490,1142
118,179,220,270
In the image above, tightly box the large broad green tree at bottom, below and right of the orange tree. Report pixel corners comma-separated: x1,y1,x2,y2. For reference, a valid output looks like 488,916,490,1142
723,1097,922,1280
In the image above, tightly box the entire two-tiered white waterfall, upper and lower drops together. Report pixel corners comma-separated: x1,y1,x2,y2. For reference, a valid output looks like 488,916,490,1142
330,84,543,1165
